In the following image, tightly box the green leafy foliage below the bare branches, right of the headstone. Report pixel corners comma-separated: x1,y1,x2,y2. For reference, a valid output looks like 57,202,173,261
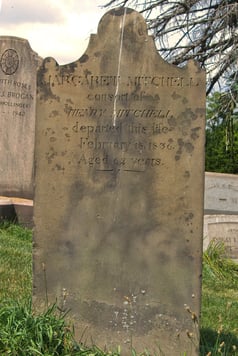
206,80,238,174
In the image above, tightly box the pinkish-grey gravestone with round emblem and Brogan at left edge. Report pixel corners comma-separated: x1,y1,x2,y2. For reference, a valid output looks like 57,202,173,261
0,36,40,198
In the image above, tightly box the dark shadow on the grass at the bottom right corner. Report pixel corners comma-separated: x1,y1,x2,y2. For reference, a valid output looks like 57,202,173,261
200,328,238,356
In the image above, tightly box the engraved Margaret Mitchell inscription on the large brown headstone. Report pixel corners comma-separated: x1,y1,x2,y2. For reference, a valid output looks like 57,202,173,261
41,71,202,174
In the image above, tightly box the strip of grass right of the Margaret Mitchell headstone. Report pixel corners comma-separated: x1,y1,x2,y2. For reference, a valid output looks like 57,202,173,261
200,241,238,356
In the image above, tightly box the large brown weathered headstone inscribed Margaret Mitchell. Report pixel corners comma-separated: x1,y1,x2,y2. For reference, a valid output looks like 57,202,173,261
34,8,205,355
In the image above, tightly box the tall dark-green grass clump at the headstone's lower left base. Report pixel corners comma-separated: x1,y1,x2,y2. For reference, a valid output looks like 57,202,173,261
0,301,121,356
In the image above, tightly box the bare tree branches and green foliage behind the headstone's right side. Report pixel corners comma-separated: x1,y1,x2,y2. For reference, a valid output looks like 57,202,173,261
104,0,238,173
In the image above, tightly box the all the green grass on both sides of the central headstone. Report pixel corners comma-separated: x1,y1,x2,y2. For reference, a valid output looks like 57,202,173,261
0,222,238,356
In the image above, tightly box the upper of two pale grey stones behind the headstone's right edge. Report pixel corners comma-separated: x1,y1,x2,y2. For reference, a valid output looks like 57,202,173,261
205,172,238,215
